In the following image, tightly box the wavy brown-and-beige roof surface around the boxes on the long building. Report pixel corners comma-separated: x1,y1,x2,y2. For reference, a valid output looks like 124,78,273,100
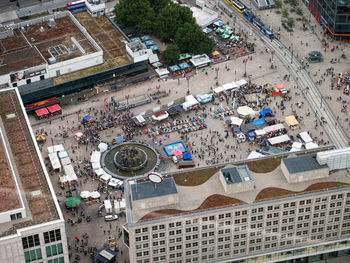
125,149,350,225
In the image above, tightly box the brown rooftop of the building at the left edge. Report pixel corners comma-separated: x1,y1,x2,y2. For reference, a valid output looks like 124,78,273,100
0,88,60,237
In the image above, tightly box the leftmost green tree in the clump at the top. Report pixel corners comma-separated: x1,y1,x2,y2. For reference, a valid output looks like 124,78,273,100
114,0,155,33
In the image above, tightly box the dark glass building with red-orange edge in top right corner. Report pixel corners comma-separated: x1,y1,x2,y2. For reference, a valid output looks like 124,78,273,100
304,0,350,37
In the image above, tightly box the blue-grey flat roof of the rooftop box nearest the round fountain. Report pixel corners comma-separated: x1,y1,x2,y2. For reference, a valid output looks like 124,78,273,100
131,178,177,201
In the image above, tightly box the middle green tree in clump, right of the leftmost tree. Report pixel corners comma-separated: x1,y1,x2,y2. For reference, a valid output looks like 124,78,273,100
154,3,195,40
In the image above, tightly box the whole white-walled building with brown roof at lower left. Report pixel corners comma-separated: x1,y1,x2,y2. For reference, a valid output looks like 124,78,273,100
0,88,69,263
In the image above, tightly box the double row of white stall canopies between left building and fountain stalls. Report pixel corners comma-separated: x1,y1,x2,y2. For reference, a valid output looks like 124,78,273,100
47,144,78,186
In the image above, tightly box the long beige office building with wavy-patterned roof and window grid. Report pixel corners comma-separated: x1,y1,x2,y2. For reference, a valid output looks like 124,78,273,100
123,149,350,263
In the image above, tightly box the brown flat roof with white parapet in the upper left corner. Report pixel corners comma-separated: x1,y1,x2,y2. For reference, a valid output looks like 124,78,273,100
0,15,96,76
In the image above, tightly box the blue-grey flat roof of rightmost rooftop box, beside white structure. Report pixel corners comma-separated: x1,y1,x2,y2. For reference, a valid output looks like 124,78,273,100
282,154,328,174
